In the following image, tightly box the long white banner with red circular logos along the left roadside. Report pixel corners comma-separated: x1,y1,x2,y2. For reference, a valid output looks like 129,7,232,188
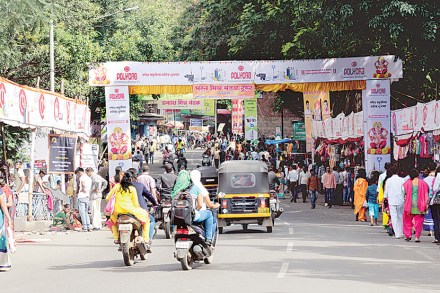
0,78,90,136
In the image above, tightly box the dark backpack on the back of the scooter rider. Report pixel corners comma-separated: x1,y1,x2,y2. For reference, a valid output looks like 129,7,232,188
170,192,195,226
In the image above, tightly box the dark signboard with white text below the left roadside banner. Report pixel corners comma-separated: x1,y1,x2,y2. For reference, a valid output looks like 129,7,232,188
47,134,77,174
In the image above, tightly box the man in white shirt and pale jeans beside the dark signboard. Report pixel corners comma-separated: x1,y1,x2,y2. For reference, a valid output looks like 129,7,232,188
75,167,92,232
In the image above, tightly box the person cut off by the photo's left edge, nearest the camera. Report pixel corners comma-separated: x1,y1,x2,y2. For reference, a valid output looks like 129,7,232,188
0,186,12,271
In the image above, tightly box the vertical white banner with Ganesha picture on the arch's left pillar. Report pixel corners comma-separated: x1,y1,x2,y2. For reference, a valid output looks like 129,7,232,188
105,86,132,176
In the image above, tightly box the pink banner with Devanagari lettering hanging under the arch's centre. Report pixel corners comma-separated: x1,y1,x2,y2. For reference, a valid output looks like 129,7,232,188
193,84,255,100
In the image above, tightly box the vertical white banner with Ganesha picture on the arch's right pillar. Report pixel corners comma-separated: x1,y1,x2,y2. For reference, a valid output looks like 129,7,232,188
362,80,391,173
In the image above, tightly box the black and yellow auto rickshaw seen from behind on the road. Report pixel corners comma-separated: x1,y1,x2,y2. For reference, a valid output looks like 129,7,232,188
217,161,280,233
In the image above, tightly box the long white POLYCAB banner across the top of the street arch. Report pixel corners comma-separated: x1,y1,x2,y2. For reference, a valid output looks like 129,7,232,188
89,55,403,86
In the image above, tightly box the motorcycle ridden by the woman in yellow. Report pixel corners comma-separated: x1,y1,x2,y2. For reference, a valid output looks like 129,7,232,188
117,214,148,266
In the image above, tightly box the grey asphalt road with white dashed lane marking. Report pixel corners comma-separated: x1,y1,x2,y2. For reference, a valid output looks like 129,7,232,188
4,152,440,293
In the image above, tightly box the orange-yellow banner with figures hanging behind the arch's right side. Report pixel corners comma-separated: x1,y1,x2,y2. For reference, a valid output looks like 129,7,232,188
303,92,330,152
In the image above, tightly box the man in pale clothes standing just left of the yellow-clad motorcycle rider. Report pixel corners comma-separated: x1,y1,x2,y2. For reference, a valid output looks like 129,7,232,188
86,167,107,230
